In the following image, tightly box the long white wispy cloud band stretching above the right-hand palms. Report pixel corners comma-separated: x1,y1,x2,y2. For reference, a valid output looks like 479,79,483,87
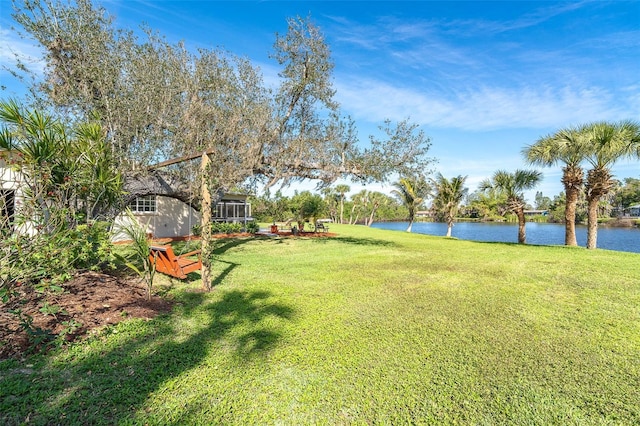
338,78,640,130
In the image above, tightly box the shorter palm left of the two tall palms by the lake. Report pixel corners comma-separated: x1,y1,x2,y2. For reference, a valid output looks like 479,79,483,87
480,170,542,244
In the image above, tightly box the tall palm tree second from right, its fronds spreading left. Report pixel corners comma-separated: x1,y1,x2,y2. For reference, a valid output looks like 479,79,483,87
523,128,588,246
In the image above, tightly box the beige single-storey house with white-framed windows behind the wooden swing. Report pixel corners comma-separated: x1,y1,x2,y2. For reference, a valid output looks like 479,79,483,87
113,194,253,241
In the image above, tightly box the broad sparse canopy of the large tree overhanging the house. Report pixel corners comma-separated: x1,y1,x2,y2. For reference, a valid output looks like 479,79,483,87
13,0,433,208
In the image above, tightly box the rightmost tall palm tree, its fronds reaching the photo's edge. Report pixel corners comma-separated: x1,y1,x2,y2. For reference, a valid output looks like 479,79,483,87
581,120,640,249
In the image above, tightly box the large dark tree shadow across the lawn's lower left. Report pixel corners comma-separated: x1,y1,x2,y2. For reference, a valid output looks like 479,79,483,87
0,282,295,425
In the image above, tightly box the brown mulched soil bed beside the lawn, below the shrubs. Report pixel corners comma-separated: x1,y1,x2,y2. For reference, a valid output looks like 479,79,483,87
0,272,171,360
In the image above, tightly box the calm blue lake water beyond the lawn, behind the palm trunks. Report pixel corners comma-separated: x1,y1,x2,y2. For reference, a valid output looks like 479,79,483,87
372,222,640,253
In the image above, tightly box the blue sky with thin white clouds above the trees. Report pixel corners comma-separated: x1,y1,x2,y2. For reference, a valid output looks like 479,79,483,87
0,0,640,202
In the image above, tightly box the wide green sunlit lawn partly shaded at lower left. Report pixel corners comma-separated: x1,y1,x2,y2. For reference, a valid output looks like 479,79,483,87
0,225,640,425
